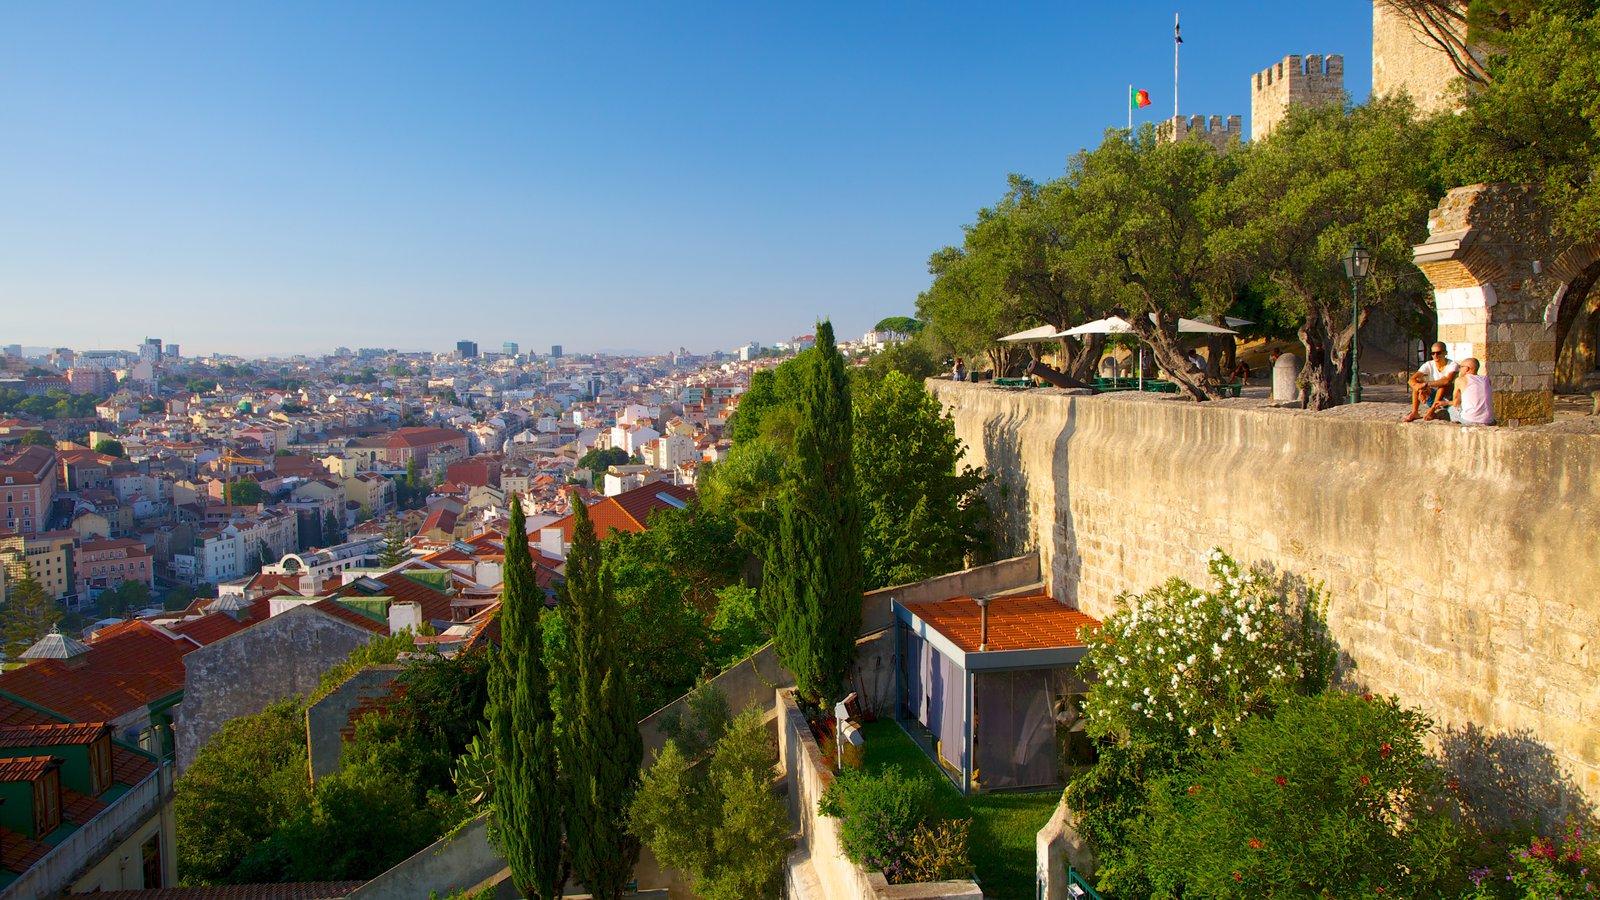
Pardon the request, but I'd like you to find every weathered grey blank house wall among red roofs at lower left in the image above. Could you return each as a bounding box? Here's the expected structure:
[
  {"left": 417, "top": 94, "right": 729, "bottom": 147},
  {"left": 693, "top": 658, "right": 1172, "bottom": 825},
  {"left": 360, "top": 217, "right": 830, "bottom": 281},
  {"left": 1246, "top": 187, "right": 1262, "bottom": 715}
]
[{"left": 173, "top": 607, "right": 373, "bottom": 773}]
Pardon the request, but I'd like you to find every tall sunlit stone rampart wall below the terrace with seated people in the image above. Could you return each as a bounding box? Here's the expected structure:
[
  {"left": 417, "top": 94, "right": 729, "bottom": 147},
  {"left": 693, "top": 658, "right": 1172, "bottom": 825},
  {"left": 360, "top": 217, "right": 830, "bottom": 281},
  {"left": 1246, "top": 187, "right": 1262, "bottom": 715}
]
[{"left": 930, "top": 381, "right": 1600, "bottom": 815}]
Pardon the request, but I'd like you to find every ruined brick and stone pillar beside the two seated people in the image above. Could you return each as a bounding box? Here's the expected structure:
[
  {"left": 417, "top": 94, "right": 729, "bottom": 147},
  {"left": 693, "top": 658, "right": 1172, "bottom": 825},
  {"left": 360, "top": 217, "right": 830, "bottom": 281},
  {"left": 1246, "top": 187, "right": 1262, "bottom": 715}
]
[{"left": 1414, "top": 184, "right": 1566, "bottom": 426}]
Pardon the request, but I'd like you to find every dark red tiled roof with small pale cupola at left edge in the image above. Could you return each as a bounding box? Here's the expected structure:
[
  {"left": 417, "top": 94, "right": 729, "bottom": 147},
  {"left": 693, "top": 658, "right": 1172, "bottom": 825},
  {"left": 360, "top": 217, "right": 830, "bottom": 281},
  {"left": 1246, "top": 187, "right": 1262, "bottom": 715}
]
[{"left": 0, "top": 618, "right": 195, "bottom": 722}]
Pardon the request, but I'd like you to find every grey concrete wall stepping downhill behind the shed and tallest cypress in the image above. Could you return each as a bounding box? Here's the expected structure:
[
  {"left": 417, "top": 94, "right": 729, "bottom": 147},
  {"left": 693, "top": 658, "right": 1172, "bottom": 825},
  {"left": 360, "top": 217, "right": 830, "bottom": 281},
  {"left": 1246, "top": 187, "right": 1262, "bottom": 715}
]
[{"left": 638, "top": 552, "right": 1038, "bottom": 761}]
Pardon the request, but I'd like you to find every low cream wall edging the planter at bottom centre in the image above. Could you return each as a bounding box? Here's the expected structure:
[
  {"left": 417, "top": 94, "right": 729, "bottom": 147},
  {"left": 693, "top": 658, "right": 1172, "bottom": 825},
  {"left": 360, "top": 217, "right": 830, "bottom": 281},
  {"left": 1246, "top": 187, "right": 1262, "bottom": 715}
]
[{"left": 774, "top": 692, "right": 982, "bottom": 900}]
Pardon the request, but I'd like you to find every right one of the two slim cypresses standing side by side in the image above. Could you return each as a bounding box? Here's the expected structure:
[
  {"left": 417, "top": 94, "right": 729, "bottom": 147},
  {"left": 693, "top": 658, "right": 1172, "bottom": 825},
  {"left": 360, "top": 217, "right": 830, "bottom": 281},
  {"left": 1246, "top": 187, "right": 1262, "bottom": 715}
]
[{"left": 560, "top": 496, "right": 645, "bottom": 900}]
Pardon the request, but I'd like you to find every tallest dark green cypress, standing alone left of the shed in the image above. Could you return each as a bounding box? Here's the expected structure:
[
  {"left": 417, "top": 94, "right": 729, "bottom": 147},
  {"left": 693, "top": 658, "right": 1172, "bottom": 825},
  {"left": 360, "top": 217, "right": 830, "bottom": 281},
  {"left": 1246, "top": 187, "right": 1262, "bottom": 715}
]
[{"left": 763, "top": 322, "right": 864, "bottom": 701}]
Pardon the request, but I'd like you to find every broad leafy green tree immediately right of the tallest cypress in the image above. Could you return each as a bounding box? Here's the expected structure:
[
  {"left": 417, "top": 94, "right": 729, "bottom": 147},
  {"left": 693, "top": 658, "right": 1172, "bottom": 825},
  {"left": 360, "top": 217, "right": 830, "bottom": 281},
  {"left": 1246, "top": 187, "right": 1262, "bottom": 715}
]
[{"left": 853, "top": 372, "right": 989, "bottom": 589}]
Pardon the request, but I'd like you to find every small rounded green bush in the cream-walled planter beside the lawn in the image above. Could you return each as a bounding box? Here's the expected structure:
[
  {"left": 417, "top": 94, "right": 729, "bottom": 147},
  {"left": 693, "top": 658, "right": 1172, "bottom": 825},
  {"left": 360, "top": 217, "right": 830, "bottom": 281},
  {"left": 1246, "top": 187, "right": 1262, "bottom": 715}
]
[{"left": 818, "top": 765, "right": 939, "bottom": 882}]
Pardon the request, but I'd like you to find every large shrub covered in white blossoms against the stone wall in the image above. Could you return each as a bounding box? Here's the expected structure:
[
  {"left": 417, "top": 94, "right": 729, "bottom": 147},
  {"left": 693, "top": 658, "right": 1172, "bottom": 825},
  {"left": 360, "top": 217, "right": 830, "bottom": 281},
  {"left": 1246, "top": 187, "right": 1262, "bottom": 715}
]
[{"left": 1067, "top": 551, "right": 1333, "bottom": 897}]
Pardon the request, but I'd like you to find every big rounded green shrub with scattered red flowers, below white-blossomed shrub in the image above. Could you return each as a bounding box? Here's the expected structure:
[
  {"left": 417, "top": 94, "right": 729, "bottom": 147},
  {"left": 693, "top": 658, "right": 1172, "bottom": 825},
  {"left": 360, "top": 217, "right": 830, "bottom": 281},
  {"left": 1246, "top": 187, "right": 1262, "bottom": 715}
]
[{"left": 1130, "top": 692, "right": 1472, "bottom": 897}]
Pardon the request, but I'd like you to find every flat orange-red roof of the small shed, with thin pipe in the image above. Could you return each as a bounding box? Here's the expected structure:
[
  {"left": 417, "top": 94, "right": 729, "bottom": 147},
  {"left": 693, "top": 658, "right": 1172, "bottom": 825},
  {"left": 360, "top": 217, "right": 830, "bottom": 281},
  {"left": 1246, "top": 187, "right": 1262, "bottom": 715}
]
[{"left": 904, "top": 594, "right": 1099, "bottom": 653}]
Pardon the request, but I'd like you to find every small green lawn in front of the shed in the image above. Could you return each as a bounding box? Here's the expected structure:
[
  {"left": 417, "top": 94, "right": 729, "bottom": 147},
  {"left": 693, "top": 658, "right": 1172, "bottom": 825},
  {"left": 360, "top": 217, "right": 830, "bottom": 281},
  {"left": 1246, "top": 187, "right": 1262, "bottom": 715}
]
[{"left": 862, "top": 721, "right": 1061, "bottom": 900}]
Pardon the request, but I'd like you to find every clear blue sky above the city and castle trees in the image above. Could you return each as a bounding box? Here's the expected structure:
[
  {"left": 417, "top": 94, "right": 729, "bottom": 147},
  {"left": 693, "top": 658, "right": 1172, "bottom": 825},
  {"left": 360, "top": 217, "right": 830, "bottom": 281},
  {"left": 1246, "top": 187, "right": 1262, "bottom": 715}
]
[{"left": 0, "top": 0, "right": 1371, "bottom": 354}]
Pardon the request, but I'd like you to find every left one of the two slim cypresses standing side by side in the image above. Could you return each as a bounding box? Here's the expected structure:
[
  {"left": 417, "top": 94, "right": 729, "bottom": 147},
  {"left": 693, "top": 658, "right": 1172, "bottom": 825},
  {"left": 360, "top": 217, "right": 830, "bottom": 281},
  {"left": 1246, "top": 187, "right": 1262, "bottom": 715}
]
[{"left": 488, "top": 504, "right": 566, "bottom": 900}]
